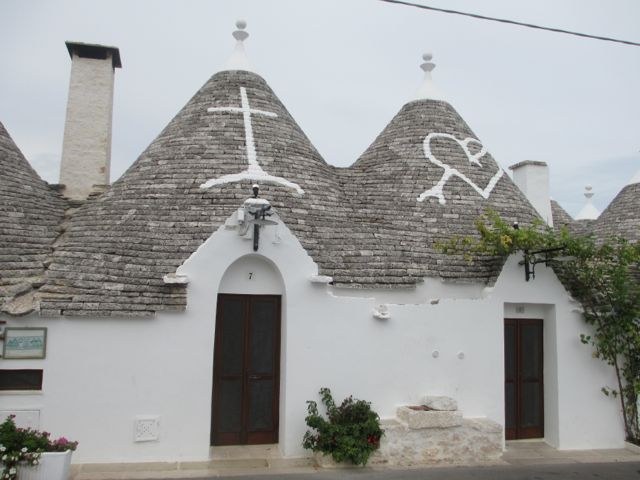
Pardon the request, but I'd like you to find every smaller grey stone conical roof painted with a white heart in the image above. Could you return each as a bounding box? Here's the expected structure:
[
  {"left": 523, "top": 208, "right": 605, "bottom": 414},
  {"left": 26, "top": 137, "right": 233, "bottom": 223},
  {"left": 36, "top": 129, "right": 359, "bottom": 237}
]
[{"left": 351, "top": 99, "right": 537, "bottom": 283}]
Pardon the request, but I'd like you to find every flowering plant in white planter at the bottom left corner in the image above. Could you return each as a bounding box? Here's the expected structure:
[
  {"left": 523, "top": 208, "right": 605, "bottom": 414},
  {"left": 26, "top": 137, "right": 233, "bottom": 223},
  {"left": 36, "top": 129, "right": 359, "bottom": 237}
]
[{"left": 0, "top": 415, "right": 78, "bottom": 480}]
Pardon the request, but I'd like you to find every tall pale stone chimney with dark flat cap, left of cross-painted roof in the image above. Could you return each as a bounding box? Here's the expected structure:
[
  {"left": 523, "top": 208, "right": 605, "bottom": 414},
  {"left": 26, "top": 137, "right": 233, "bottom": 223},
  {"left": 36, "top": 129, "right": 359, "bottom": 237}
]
[{"left": 60, "top": 42, "right": 122, "bottom": 200}]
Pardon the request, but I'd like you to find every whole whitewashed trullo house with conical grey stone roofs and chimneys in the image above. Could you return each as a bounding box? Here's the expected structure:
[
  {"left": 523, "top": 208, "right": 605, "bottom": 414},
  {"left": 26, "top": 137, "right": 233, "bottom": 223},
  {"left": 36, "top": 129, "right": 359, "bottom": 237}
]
[{"left": 0, "top": 23, "right": 640, "bottom": 463}]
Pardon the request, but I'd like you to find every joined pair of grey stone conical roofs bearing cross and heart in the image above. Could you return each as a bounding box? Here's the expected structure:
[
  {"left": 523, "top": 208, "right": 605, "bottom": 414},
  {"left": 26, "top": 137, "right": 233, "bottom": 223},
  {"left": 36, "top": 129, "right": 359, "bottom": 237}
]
[{"left": 41, "top": 57, "right": 536, "bottom": 315}]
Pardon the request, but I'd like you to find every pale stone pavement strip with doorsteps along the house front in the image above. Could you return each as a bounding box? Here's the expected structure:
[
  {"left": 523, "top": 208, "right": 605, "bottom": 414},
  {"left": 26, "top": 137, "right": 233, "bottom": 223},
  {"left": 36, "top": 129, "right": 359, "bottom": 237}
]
[{"left": 71, "top": 441, "right": 640, "bottom": 480}]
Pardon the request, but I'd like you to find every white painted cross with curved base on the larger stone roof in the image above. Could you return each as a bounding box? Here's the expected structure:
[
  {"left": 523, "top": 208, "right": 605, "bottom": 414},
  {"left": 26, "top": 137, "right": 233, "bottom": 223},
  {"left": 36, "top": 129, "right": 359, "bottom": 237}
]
[{"left": 200, "top": 87, "right": 304, "bottom": 194}]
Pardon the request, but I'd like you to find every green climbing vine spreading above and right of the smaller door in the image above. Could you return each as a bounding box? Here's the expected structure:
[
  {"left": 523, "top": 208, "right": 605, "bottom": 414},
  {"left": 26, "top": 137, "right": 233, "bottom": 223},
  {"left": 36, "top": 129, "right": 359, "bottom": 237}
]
[{"left": 440, "top": 212, "right": 640, "bottom": 444}]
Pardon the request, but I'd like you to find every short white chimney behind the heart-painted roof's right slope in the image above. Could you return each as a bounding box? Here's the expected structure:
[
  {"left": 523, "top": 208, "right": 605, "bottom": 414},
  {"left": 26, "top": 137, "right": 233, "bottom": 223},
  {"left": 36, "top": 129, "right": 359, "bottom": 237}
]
[{"left": 509, "top": 160, "right": 553, "bottom": 227}]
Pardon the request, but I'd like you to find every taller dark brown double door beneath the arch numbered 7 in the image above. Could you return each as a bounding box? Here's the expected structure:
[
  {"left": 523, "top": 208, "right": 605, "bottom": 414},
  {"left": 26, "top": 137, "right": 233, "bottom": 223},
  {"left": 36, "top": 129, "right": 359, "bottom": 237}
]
[{"left": 211, "top": 294, "right": 280, "bottom": 445}]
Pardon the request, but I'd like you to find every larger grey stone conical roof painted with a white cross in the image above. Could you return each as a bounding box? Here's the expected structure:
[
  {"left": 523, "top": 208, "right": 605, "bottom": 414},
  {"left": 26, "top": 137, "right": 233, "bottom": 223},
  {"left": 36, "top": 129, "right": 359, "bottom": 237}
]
[{"left": 42, "top": 70, "right": 347, "bottom": 315}]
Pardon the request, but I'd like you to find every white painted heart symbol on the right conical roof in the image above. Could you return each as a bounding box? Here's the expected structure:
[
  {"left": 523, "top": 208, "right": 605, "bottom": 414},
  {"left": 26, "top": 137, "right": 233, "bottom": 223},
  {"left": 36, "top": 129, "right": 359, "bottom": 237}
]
[{"left": 418, "top": 133, "right": 504, "bottom": 205}]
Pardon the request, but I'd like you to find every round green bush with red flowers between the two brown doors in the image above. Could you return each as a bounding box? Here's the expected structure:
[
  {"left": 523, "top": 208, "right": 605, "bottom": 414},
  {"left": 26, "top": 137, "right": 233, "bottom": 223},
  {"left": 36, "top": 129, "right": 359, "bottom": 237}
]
[{"left": 302, "top": 388, "right": 384, "bottom": 465}]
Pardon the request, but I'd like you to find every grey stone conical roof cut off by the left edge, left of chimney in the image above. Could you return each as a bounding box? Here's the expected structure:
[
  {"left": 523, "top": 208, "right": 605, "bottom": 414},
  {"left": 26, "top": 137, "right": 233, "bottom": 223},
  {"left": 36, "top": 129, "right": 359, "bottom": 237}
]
[{"left": 0, "top": 123, "right": 66, "bottom": 314}]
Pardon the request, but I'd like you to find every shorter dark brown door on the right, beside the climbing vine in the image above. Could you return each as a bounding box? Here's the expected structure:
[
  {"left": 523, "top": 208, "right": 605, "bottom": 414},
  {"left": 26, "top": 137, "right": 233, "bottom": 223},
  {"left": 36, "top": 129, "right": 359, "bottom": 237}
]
[{"left": 504, "top": 318, "right": 544, "bottom": 440}]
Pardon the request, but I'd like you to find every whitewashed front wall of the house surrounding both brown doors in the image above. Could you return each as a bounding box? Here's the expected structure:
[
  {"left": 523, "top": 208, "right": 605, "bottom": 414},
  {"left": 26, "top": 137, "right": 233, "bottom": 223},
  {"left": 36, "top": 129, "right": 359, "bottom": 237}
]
[{"left": 0, "top": 216, "right": 624, "bottom": 463}]
